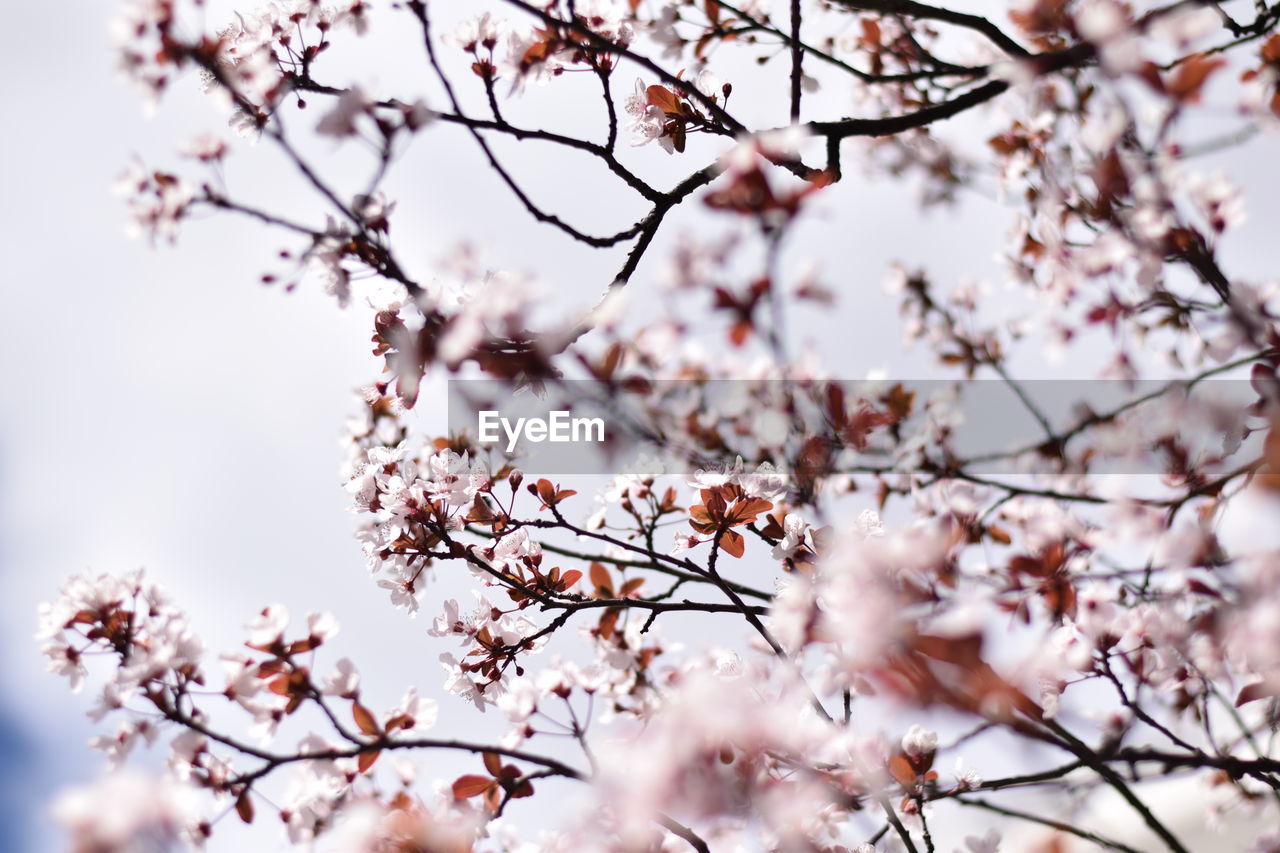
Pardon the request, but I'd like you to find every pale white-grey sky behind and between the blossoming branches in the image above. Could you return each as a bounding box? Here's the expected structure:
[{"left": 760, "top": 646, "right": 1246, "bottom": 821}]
[{"left": 0, "top": 1, "right": 1280, "bottom": 850}]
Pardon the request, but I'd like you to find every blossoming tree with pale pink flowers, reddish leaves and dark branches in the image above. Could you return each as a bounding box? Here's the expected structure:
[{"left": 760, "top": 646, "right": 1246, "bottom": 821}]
[{"left": 40, "top": 0, "right": 1280, "bottom": 853}]
